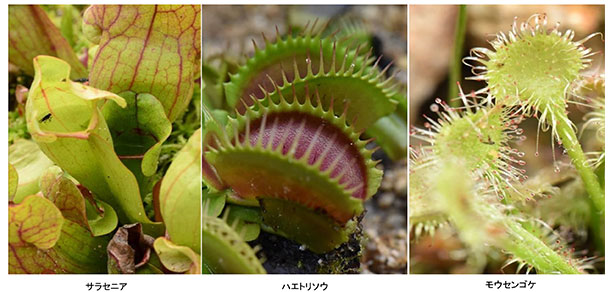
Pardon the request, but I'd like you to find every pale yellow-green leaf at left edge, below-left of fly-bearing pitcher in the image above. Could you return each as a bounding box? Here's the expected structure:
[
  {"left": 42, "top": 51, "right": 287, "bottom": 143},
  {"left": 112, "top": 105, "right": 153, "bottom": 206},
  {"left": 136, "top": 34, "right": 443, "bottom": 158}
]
[{"left": 9, "top": 139, "right": 53, "bottom": 203}]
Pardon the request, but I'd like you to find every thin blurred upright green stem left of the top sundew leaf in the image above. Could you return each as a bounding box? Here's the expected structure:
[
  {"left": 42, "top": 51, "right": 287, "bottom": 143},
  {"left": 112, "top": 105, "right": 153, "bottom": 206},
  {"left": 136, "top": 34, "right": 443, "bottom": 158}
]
[{"left": 448, "top": 5, "right": 467, "bottom": 107}]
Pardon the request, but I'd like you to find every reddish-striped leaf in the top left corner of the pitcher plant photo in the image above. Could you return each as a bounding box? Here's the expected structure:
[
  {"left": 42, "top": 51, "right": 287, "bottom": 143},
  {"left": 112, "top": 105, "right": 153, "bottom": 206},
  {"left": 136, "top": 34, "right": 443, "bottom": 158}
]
[{"left": 9, "top": 5, "right": 88, "bottom": 79}]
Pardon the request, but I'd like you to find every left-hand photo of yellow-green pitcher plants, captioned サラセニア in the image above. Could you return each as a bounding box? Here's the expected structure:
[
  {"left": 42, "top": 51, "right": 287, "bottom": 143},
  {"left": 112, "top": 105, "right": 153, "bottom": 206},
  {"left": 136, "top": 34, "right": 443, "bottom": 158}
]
[{"left": 8, "top": 5, "right": 202, "bottom": 274}]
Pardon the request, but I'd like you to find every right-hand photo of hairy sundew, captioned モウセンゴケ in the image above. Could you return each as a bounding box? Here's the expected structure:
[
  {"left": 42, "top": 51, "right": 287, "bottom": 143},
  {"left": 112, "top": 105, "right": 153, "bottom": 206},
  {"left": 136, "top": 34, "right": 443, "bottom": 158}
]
[{"left": 409, "top": 5, "right": 606, "bottom": 274}]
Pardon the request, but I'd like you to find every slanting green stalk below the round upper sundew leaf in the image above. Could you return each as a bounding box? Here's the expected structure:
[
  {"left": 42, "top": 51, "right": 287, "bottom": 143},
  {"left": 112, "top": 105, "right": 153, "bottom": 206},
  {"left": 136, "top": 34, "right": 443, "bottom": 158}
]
[{"left": 555, "top": 113, "right": 604, "bottom": 216}]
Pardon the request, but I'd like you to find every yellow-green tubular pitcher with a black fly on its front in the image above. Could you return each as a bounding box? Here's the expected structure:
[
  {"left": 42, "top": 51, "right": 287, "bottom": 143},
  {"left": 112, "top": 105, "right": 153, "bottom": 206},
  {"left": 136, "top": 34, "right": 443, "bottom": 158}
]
[{"left": 26, "top": 56, "right": 162, "bottom": 234}]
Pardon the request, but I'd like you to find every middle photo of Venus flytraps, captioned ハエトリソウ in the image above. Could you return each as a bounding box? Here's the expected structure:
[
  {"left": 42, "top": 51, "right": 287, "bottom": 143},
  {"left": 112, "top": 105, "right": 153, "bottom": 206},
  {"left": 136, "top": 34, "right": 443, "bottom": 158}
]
[{"left": 202, "top": 5, "right": 408, "bottom": 274}]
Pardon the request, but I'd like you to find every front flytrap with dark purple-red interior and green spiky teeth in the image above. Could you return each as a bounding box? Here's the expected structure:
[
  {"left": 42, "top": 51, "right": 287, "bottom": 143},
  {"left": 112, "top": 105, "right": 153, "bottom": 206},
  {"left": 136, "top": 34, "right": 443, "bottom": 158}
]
[{"left": 205, "top": 91, "right": 382, "bottom": 253}]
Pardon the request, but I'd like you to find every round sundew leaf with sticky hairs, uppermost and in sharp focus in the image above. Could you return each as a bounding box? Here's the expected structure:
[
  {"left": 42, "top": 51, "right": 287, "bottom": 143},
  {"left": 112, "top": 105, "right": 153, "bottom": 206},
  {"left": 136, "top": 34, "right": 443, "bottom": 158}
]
[{"left": 463, "top": 14, "right": 598, "bottom": 117}]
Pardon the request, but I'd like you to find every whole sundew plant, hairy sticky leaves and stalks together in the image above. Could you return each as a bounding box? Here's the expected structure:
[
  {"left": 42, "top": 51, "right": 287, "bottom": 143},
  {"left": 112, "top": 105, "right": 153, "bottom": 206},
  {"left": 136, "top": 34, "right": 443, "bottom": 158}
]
[{"left": 409, "top": 14, "right": 605, "bottom": 274}]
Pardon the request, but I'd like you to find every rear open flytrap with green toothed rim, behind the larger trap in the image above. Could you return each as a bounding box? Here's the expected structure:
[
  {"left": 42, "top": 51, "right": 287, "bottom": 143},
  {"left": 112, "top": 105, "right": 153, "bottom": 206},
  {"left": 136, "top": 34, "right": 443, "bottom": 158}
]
[{"left": 224, "top": 27, "right": 372, "bottom": 113}]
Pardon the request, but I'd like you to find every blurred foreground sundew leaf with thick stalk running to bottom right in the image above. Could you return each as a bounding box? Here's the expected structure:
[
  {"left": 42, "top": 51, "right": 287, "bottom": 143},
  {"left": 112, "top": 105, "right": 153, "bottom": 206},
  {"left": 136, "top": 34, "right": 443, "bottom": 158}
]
[{"left": 437, "top": 156, "right": 579, "bottom": 274}]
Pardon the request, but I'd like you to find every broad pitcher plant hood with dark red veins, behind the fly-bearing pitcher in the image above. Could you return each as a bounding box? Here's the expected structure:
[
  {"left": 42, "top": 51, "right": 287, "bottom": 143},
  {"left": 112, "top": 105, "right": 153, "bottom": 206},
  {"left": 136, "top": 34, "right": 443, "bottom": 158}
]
[{"left": 83, "top": 5, "right": 201, "bottom": 122}]
